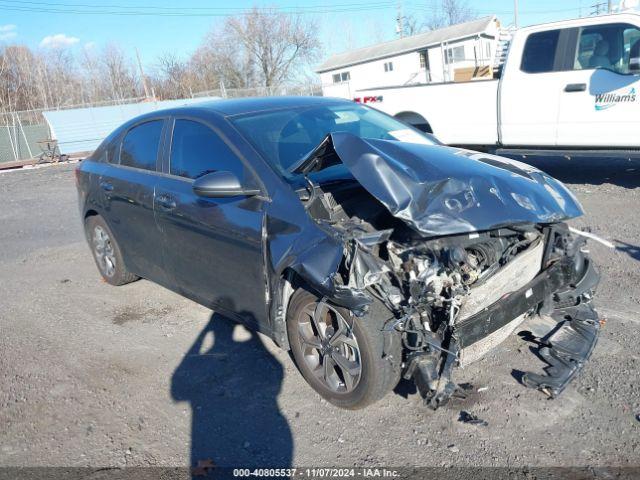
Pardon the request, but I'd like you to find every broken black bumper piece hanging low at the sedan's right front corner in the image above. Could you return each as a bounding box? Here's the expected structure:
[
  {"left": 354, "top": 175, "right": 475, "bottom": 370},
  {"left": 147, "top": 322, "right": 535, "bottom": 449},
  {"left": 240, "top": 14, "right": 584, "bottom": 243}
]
[{"left": 522, "top": 304, "right": 600, "bottom": 398}]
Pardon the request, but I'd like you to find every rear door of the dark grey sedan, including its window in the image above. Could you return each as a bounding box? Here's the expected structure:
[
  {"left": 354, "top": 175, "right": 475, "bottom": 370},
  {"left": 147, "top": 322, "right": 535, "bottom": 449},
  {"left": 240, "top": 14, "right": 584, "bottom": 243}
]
[{"left": 98, "top": 118, "right": 166, "bottom": 284}]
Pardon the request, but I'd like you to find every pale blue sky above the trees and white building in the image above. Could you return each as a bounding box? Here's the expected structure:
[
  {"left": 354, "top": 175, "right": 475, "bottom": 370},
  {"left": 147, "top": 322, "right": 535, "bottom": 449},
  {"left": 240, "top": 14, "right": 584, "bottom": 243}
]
[{"left": 0, "top": 0, "right": 596, "bottom": 67}]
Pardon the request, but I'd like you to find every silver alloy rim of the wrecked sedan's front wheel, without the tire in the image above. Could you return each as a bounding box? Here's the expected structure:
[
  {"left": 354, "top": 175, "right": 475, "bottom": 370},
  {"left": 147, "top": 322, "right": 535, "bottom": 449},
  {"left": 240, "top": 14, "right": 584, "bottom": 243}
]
[{"left": 298, "top": 301, "right": 362, "bottom": 393}]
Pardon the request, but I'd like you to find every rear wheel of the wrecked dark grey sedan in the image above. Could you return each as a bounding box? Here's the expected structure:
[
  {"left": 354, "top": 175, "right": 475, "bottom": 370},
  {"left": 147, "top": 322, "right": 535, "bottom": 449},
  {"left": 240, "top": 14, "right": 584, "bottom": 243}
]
[{"left": 84, "top": 215, "right": 139, "bottom": 286}]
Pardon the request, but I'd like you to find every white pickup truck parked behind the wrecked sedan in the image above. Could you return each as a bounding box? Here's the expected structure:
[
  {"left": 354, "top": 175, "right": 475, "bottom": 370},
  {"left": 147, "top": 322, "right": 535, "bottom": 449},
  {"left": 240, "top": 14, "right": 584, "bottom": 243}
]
[{"left": 355, "top": 13, "right": 640, "bottom": 151}]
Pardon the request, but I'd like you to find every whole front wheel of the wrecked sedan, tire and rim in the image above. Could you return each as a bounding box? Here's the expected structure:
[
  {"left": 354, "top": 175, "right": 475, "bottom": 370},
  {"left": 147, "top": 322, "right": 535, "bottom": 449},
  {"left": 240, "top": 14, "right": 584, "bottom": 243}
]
[{"left": 287, "top": 288, "right": 402, "bottom": 410}]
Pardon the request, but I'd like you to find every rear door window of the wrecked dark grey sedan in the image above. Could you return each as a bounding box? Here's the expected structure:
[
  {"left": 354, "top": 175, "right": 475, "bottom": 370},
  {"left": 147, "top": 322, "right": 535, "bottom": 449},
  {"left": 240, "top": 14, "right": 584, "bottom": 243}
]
[{"left": 120, "top": 120, "right": 164, "bottom": 171}]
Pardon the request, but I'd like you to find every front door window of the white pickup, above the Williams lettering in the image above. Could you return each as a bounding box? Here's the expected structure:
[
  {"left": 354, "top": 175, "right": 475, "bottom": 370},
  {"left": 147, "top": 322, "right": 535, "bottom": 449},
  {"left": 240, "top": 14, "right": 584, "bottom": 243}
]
[{"left": 574, "top": 23, "right": 640, "bottom": 74}]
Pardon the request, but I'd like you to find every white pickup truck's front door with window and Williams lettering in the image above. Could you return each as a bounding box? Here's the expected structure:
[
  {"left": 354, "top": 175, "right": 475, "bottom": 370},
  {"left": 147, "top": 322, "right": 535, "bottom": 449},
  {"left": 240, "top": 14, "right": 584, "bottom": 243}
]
[{"left": 557, "top": 23, "right": 640, "bottom": 147}]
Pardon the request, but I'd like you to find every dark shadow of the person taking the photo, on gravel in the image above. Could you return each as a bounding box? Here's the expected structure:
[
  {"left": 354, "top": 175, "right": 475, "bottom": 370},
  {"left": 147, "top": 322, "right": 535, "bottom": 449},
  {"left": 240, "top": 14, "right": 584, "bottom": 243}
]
[{"left": 171, "top": 314, "right": 293, "bottom": 468}]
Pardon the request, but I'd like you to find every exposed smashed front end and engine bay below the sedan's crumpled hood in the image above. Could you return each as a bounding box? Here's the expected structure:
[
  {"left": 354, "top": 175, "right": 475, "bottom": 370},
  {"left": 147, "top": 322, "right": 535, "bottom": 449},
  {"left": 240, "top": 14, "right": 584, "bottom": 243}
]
[{"left": 299, "top": 176, "right": 599, "bottom": 408}]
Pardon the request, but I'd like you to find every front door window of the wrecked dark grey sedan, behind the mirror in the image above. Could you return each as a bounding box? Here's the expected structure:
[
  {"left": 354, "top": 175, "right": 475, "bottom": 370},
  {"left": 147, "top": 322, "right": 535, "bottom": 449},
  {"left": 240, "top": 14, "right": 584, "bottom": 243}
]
[{"left": 170, "top": 119, "right": 244, "bottom": 181}]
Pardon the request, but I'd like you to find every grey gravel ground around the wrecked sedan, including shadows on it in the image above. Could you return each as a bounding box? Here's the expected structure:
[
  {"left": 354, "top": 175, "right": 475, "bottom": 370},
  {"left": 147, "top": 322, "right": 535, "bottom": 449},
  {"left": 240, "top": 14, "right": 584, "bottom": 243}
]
[{"left": 0, "top": 159, "right": 640, "bottom": 467}]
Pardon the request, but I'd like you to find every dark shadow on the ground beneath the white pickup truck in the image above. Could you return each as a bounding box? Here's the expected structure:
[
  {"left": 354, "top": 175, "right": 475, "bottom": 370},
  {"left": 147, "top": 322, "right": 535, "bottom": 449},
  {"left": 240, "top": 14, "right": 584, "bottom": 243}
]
[{"left": 500, "top": 155, "right": 640, "bottom": 188}]
